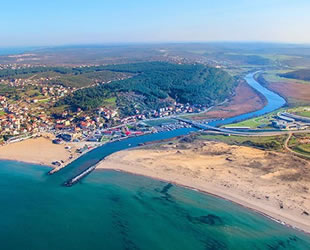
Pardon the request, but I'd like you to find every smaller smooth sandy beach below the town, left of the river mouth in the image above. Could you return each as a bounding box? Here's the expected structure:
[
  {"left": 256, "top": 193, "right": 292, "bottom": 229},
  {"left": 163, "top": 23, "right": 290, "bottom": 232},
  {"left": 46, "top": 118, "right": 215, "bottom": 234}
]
[{"left": 0, "top": 137, "right": 77, "bottom": 166}]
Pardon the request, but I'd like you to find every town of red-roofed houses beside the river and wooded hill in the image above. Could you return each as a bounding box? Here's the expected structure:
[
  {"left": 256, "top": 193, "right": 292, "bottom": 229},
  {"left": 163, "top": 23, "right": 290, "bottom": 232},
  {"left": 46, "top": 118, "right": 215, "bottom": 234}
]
[{"left": 0, "top": 65, "right": 207, "bottom": 147}]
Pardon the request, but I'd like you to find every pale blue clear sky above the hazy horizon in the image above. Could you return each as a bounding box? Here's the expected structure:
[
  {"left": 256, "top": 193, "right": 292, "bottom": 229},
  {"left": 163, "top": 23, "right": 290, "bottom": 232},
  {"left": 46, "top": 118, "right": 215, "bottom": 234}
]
[{"left": 0, "top": 0, "right": 310, "bottom": 47}]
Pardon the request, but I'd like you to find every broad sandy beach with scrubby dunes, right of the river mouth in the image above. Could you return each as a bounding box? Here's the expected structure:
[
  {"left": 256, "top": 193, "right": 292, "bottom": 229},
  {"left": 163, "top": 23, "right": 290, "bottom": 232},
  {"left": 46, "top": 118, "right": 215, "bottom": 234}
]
[{"left": 97, "top": 141, "right": 310, "bottom": 233}]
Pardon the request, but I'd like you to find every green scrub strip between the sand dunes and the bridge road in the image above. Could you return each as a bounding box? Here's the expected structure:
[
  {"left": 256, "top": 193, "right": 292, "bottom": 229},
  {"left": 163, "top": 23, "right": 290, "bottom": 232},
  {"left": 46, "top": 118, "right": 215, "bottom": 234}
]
[{"left": 197, "top": 133, "right": 287, "bottom": 151}]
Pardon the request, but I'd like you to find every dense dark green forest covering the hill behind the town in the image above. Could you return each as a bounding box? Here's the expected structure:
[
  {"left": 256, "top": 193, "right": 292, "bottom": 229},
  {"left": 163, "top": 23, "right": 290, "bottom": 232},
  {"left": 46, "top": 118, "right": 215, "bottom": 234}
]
[{"left": 57, "top": 62, "right": 235, "bottom": 115}]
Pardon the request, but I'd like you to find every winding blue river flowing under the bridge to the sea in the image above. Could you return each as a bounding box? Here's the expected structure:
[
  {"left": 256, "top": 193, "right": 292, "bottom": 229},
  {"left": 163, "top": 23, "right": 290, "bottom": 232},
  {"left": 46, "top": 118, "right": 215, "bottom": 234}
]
[{"left": 52, "top": 72, "right": 286, "bottom": 187}]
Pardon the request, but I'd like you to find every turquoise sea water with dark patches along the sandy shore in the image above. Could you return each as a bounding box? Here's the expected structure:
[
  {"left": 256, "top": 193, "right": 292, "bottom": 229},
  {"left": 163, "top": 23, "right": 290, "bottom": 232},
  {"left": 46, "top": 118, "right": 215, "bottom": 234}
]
[{"left": 0, "top": 161, "right": 310, "bottom": 250}]
